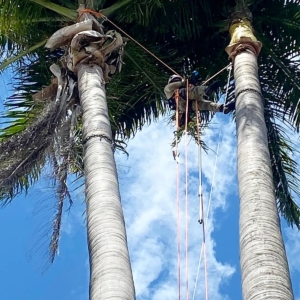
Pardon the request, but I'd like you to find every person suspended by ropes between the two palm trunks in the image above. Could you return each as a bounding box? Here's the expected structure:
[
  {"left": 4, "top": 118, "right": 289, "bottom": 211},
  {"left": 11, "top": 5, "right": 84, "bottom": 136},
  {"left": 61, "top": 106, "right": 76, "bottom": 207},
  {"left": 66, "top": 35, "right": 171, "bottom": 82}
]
[{"left": 164, "top": 71, "right": 235, "bottom": 126}]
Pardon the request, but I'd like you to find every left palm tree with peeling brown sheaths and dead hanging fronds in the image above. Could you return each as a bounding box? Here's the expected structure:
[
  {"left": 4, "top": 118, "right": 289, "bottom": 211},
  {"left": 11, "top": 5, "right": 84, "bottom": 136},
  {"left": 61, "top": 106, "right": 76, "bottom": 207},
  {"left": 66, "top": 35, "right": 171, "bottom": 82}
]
[{"left": 1, "top": 1, "right": 168, "bottom": 299}]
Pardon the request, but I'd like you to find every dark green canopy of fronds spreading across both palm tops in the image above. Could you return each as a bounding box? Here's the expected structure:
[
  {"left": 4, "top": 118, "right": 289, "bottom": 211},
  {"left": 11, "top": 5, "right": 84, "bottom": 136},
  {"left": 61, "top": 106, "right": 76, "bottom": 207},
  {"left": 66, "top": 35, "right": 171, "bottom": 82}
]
[{"left": 0, "top": 0, "right": 300, "bottom": 264}]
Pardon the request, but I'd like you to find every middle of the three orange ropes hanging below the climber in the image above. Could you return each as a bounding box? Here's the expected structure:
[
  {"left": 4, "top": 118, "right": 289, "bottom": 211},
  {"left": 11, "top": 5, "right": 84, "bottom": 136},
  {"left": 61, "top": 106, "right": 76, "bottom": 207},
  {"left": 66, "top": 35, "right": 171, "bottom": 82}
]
[{"left": 185, "top": 79, "right": 189, "bottom": 300}]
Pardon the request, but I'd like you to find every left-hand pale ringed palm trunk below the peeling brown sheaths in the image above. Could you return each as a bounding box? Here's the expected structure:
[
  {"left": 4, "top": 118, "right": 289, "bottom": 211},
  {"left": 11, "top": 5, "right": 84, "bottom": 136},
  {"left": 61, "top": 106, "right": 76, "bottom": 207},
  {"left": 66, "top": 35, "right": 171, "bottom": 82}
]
[{"left": 77, "top": 64, "right": 135, "bottom": 300}]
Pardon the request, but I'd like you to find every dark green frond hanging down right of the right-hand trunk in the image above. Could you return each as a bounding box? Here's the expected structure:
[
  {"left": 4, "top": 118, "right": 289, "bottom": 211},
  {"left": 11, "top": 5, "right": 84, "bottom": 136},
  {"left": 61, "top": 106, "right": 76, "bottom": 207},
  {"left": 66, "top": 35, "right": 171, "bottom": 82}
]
[{"left": 225, "top": 74, "right": 300, "bottom": 229}]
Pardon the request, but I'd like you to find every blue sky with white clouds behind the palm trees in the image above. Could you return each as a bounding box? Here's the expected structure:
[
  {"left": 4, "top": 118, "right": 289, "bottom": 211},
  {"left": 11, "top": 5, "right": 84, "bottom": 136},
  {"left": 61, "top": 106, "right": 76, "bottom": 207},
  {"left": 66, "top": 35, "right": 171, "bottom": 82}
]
[{"left": 0, "top": 71, "right": 300, "bottom": 300}]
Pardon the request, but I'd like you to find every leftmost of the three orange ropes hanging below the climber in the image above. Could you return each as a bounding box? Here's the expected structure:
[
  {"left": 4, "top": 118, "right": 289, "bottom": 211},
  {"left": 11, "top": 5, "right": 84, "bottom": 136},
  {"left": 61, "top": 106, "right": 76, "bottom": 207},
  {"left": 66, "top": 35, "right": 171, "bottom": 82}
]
[{"left": 175, "top": 90, "right": 181, "bottom": 300}]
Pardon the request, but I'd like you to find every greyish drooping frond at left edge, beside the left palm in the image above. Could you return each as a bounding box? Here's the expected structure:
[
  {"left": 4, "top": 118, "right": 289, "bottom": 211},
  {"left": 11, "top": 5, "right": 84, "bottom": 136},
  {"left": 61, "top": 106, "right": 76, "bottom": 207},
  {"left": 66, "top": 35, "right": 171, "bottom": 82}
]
[{"left": 0, "top": 102, "right": 59, "bottom": 205}]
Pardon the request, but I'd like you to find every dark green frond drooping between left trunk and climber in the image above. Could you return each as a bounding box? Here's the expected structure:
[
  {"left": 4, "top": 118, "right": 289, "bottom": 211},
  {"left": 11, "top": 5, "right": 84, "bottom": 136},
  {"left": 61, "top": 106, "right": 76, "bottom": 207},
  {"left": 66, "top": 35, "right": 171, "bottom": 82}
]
[{"left": 107, "top": 42, "right": 172, "bottom": 139}]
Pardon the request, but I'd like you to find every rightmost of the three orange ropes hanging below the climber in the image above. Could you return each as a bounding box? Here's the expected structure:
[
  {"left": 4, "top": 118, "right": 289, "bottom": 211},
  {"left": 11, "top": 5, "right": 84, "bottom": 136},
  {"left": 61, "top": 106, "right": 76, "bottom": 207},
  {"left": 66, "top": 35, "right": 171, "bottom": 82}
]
[{"left": 195, "top": 99, "right": 208, "bottom": 300}]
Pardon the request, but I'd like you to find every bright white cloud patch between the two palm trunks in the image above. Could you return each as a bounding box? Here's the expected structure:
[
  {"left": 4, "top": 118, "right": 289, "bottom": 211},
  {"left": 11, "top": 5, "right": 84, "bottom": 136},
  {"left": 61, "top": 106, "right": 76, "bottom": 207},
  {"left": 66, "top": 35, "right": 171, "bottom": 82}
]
[{"left": 117, "top": 113, "right": 236, "bottom": 300}]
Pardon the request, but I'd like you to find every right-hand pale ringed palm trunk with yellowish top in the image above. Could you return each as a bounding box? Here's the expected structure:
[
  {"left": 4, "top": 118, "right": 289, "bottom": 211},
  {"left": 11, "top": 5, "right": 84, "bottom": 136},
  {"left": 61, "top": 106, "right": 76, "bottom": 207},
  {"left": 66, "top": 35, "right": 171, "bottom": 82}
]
[{"left": 226, "top": 13, "right": 294, "bottom": 300}]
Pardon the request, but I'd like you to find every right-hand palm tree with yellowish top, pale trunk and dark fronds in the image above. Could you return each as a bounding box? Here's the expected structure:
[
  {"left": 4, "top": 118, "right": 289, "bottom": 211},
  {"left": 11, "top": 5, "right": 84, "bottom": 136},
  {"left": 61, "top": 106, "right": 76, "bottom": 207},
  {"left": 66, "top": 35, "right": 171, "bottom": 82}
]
[{"left": 126, "top": 1, "right": 300, "bottom": 299}]
